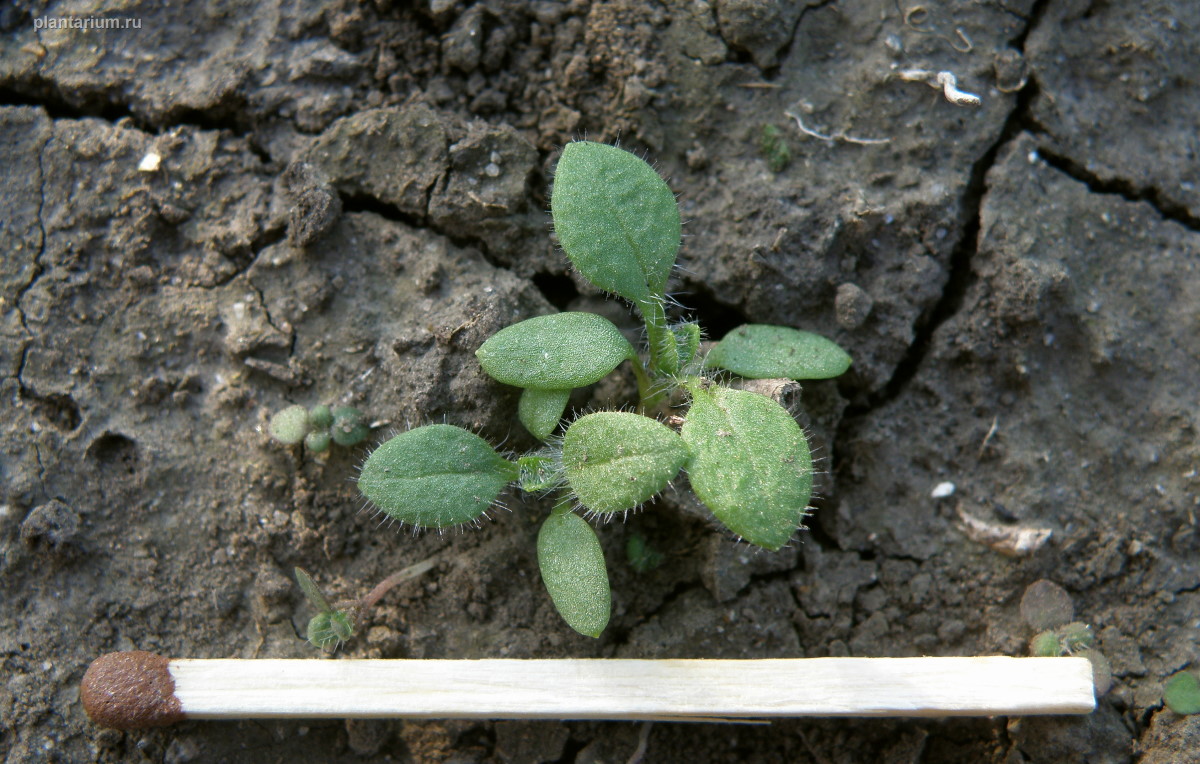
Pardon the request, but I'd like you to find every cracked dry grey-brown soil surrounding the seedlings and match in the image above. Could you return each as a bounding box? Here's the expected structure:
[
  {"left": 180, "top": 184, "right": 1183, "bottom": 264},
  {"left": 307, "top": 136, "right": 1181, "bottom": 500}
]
[{"left": 0, "top": 0, "right": 1200, "bottom": 764}]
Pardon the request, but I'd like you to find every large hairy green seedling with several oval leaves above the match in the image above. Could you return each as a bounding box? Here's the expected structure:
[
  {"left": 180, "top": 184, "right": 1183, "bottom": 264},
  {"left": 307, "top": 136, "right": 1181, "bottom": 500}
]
[{"left": 358, "top": 142, "right": 850, "bottom": 637}]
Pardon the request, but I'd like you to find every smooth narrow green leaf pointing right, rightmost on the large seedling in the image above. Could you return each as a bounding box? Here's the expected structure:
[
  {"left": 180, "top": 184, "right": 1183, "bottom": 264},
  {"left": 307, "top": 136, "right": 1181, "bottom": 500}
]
[{"left": 704, "top": 324, "right": 851, "bottom": 379}]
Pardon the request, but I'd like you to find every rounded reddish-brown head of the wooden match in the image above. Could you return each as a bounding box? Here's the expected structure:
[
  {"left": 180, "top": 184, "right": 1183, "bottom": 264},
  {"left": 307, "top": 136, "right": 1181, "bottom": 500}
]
[{"left": 79, "top": 650, "right": 184, "bottom": 729}]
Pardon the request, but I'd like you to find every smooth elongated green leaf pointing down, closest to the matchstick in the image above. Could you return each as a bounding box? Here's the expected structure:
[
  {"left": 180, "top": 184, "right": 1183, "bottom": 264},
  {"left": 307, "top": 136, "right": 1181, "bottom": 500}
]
[{"left": 538, "top": 510, "right": 612, "bottom": 637}]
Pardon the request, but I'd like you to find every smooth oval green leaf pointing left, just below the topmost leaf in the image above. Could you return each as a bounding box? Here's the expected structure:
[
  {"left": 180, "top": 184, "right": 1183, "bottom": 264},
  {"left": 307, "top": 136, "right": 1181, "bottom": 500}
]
[{"left": 475, "top": 313, "right": 635, "bottom": 390}]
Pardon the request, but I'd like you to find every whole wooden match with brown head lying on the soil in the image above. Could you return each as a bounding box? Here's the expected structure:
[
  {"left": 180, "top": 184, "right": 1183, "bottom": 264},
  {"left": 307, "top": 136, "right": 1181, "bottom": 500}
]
[{"left": 80, "top": 651, "right": 1096, "bottom": 729}]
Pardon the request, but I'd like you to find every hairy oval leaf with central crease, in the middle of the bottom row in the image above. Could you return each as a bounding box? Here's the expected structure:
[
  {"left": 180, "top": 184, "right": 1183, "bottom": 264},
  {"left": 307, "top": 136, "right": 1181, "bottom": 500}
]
[{"left": 563, "top": 411, "right": 688, "bottom": 512}]
